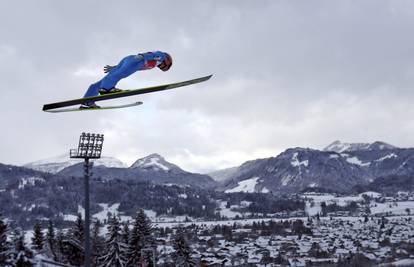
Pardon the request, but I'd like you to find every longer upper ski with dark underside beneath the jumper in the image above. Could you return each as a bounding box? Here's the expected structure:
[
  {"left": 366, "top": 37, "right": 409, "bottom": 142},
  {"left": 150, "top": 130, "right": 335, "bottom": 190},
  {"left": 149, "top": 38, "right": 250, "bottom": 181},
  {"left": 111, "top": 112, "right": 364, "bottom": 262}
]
[{"left": 43, "top": 75, "right": 213, "bottom": 111}]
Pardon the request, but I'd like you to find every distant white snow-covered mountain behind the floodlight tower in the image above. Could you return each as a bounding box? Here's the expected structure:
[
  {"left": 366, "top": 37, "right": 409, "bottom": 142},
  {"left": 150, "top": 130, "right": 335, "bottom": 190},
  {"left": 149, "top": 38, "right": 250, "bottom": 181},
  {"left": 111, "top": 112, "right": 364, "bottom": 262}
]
[{"left": 24, "top": 153, "right": 127, "bottom": 173}]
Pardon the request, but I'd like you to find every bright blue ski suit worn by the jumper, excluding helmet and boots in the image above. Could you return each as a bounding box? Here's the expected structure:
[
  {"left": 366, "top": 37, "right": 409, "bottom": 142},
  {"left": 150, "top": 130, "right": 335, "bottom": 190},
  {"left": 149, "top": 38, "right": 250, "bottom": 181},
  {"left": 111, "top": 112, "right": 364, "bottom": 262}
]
[{"left": 84, "top": 51, "right": 166, "bottom": 97}]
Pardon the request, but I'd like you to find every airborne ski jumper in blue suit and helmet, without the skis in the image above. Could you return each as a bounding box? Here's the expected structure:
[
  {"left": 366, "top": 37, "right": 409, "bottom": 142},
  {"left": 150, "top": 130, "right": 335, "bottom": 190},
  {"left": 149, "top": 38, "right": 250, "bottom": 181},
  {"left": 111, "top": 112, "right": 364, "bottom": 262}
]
[{"left": 80, "top": 51, "right": 172, "bottom": 109}]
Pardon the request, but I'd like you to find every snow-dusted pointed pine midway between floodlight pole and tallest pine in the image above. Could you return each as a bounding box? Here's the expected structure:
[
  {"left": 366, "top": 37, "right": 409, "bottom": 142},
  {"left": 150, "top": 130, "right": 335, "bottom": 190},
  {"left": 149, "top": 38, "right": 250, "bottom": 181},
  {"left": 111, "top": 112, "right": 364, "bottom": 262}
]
[{"left": 100, "top": 216, "right": 126, "bottom": 267}]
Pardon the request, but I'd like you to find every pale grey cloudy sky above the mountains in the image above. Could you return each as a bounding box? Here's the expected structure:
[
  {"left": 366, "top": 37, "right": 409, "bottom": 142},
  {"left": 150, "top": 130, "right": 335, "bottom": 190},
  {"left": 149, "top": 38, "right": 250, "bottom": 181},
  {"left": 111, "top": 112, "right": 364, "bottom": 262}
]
[{"left": 0, "top": 0, "right": 414, "bottom": 172}]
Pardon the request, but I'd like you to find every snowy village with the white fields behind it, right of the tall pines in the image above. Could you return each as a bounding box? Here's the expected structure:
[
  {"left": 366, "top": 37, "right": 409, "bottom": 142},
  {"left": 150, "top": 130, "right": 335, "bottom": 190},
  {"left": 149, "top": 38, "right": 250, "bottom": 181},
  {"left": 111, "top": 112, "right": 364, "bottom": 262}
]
[{"left": 154, "top": 192, "right": 414, "bottom": 266}]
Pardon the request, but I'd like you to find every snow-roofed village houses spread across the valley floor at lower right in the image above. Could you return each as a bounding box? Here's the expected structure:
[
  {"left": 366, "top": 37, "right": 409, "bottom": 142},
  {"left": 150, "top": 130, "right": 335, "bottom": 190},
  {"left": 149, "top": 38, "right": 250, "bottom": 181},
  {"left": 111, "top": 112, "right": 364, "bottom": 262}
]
[{"left": 158, "top": 216, "right": 414, "bottom": 266}]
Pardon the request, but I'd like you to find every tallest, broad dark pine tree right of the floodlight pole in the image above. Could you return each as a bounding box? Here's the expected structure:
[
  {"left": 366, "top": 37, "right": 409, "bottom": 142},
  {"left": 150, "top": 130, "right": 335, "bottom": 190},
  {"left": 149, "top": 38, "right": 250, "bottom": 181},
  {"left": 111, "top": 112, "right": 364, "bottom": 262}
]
[{"left": 127, "top": 209, "right": 155, "bottom": 266}]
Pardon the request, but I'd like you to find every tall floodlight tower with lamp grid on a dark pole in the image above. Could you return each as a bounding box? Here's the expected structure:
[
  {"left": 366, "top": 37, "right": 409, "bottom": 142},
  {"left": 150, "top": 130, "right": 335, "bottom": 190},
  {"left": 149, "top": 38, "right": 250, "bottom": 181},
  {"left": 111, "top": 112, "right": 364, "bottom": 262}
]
[{"left": 70, "top": 133, "right": 104, "bottom": 267}]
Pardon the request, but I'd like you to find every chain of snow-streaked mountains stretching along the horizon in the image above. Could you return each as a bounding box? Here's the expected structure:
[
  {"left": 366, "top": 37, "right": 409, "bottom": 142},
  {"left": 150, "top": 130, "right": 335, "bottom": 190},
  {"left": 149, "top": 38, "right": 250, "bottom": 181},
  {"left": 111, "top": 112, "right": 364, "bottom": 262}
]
[{"left": 15, "top": 141, "right": 414, "bottom": 193}]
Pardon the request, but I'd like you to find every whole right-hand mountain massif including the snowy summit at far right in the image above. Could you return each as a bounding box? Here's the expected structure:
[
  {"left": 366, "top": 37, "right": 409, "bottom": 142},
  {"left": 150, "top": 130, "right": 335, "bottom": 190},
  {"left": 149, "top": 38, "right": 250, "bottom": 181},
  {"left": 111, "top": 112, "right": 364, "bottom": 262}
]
[{"left": 221, "top": 142, "right": 414, "bottom": 193}]
